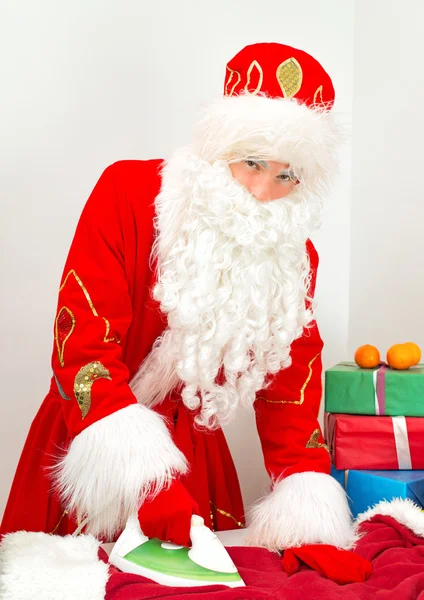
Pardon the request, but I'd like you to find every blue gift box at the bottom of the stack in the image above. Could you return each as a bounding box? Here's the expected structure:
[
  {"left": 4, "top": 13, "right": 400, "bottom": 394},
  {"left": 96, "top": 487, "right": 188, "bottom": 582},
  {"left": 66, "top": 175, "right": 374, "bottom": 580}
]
[{"left": 331, "top": 467, "right": 424, "bottom": 517}]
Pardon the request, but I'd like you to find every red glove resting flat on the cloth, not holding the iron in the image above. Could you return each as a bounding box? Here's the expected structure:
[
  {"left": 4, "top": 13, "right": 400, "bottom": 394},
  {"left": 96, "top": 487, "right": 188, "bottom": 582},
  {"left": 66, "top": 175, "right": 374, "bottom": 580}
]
[{"left": 282, "top": 544, "right": 372, "bottom": 585}]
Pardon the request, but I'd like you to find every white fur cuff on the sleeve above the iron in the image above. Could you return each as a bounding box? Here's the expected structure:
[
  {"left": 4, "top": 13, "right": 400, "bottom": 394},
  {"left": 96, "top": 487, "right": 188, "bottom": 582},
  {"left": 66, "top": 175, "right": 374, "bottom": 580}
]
[{"left": 54, "top": 404, "right": 187, "bottom": 541}]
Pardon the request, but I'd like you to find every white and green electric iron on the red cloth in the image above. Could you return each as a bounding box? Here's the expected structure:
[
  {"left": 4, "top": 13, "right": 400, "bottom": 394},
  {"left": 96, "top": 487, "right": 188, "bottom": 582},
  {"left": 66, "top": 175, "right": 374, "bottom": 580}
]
[{"left": 109, "top": 515, "right": 245, "bottom": 587}]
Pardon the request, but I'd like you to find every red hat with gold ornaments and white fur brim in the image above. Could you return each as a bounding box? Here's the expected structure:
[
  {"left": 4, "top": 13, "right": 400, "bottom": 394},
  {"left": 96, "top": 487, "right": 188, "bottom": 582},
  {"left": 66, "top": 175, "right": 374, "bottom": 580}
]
[{"left": 194, "top": 43, "right": 341, "bottom": 192}]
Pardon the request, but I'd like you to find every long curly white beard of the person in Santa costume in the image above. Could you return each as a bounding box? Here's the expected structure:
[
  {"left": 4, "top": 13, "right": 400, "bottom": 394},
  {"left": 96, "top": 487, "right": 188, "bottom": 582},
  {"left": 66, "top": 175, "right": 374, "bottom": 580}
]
[{"left": 131, "top": 150, "right": 321, "bottom": 428}]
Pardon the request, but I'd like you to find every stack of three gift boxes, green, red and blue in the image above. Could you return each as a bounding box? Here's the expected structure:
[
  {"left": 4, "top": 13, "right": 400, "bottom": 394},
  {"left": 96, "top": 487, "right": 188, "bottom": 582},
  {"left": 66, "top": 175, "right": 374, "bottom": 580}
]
[{"left": 325, "top": 362, "right": 424, "bottom": 516}]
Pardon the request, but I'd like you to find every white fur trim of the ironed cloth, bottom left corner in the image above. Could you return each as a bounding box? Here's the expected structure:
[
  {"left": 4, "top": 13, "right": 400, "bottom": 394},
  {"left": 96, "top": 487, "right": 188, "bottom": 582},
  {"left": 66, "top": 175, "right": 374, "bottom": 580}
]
[{"left": 0, "top": 531, "right": 109, "bottom": 600}]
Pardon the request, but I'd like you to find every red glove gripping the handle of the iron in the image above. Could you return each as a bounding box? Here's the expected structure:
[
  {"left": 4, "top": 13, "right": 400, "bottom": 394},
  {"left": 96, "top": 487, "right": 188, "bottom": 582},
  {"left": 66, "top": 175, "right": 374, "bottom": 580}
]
[{"left": 138, "top": 479, "right": 199, "bottom": 546}]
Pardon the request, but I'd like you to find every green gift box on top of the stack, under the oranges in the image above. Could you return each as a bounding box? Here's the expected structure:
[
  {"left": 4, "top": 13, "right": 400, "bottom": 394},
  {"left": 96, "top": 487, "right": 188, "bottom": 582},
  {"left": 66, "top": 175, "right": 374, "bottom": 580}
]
[{"left": 325, "top": 362, "right": 424, "bottom": 417}]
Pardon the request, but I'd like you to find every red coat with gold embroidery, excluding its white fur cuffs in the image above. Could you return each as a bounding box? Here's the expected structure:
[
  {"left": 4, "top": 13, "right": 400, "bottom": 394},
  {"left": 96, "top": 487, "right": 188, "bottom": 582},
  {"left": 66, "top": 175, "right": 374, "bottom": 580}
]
[{"left": 1, "top": 160, "right": 330, "bottom": 534}]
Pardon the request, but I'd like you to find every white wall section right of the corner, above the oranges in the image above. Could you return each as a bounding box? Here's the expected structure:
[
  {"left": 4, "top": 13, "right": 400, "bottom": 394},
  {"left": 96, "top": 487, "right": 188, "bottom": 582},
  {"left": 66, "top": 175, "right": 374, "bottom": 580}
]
[{"left": 348, "top": 0, "right": 424, "bottom": 356}]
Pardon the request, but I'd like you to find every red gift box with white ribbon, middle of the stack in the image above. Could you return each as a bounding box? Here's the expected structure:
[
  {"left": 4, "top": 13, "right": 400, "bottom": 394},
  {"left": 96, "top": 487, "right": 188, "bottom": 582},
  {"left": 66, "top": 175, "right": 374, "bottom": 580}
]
[{"left": 325, "top": 414, "right": 424, "bottom": 470}]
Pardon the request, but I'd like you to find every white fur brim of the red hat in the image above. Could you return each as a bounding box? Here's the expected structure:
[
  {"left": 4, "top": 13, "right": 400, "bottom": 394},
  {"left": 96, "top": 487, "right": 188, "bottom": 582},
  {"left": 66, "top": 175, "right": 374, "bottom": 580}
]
[{"left": 194, "top": 94, "right": 342, "bottom": 193}]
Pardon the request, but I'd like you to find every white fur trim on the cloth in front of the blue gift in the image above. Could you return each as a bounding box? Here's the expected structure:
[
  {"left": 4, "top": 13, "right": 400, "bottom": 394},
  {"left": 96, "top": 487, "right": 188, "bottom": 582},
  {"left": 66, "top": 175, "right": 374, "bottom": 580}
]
[{"left": 354, "top": 498, "right": 424, "bottom": 537}]
